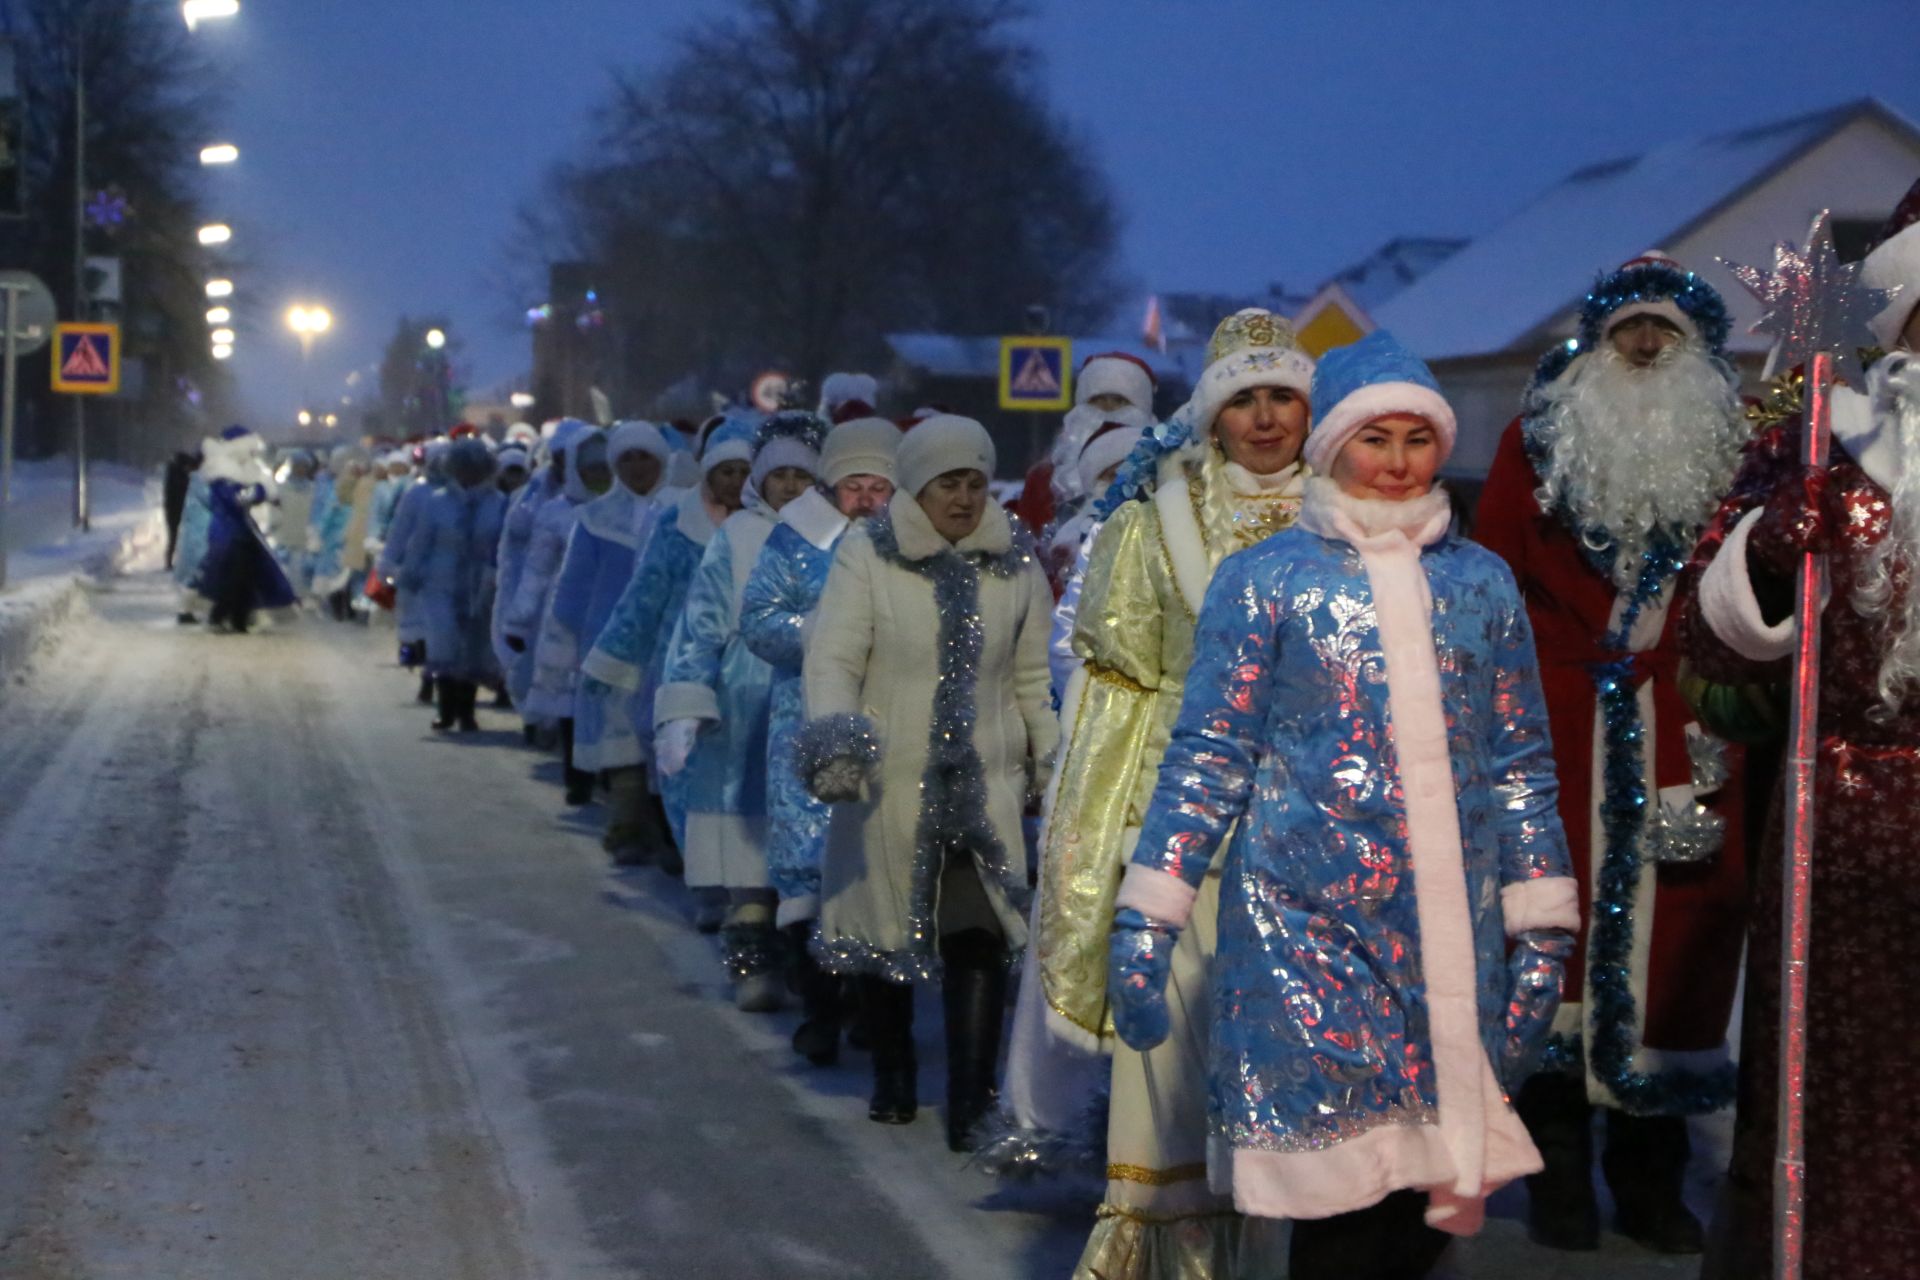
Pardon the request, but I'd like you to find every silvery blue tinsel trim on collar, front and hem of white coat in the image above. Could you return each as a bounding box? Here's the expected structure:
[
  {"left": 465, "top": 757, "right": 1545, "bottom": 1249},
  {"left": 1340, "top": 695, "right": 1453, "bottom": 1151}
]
[{"left": 803, "top": 514, "right": 1039, "bottom": 983}]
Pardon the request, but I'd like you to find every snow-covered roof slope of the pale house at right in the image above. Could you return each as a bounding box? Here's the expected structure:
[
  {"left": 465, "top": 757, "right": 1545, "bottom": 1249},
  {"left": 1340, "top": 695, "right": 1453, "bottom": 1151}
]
[{"left": 1373, "top": 98, "right": 1912, "bottom": 359}]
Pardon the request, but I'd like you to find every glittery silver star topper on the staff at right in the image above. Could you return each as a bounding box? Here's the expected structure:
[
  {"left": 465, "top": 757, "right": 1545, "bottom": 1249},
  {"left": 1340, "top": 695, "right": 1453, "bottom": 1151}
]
[{"left": 1716, "top": 209, "right": 1901, "bottom": 388}]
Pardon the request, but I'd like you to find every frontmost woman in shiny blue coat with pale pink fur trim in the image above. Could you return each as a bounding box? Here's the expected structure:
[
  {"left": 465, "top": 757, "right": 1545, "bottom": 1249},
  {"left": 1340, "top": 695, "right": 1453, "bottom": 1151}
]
[{"left": 1110, "top": 332, "right": 1578, "bottom": 1280}]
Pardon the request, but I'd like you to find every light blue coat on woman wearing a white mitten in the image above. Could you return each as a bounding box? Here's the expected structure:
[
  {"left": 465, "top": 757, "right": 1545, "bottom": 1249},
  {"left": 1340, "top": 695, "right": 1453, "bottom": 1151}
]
[{"left": 653, "top": 505, "right": 774, "bottom": 818}]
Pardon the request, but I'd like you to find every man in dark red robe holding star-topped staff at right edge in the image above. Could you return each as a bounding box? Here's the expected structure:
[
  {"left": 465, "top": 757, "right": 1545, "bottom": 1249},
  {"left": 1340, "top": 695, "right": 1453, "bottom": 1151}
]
[{"left": 1682, "top": 182, "right": 1920, "bottom": 1280}]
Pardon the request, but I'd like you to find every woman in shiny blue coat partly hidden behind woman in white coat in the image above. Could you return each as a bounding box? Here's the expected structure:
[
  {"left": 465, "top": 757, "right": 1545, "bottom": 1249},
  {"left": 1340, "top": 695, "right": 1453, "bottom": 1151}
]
[{"left": 739, "top": 418, "right": 900, "bottom": 1067}]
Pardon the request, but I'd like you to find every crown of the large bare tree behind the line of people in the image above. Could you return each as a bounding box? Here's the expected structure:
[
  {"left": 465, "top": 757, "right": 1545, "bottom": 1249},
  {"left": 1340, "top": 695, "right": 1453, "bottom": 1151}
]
[{"left": 516, "top": 0, "right": 1116, "bottom": 410}]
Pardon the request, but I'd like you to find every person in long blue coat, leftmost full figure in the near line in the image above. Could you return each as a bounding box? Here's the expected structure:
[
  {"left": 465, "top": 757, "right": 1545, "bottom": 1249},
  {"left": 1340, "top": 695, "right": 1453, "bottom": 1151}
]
[{"left": 396, "top": 438, "right": 507, "bottom": 733}]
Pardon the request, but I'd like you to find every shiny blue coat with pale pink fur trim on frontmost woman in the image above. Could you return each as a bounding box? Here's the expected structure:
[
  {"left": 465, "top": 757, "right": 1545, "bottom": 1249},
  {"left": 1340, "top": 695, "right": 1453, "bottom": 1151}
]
[{"left": 1121, "top": 482, "right": 1576, "bottom": 1230}]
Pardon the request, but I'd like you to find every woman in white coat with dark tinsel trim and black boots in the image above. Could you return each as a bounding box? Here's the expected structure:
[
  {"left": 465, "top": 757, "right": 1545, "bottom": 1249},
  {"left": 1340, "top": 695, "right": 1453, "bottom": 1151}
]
[{"left": 795, "top": 415, "right": 1058, "bottom": 1150}]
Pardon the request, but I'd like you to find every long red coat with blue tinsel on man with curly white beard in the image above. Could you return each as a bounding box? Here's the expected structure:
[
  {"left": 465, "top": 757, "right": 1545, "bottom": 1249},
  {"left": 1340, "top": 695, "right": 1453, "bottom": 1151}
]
[{"left": 1475, "top": 418, "right": 1747, "bottom": 1115}]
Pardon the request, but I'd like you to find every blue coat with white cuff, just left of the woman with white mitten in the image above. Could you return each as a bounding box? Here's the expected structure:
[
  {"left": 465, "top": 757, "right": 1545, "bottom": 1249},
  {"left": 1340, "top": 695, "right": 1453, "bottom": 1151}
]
[{"left": 580, "top": 489, "right": 718, "bottom": 842}]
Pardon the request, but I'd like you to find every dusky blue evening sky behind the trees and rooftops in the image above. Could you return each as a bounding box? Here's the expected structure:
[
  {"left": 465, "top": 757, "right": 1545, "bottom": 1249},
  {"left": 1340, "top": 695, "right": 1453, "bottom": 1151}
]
[{"left": 198, "top": 0, "right": 1920, "bottom": 428}]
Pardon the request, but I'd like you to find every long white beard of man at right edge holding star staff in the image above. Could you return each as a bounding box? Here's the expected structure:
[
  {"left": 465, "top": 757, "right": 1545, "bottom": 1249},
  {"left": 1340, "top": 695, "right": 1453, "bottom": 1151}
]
[{"left": 1853, "top": 351, "right": 1920, "bottom": 716}]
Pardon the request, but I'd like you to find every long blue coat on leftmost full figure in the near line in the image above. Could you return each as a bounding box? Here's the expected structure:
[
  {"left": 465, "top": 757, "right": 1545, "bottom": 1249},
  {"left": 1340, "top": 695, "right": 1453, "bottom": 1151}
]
[{"left": 394, "top": 480, "right": 507, "bottom": 683}]
